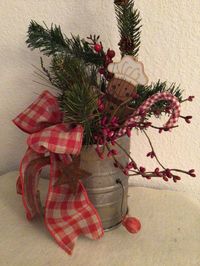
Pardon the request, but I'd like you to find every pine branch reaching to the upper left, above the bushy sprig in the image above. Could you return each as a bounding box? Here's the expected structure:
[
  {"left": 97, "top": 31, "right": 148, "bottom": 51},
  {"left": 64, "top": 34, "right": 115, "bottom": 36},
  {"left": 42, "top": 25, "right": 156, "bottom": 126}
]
[{"left": 26, "top": 21, "right": 105, "bottom": 67}]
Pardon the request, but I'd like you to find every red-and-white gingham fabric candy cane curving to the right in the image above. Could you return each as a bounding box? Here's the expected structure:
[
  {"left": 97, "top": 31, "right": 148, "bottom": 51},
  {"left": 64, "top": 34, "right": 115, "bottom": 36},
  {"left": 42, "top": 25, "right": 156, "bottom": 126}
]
[{"left": 118, "top": 92, "right": 180, "bottom": 136}]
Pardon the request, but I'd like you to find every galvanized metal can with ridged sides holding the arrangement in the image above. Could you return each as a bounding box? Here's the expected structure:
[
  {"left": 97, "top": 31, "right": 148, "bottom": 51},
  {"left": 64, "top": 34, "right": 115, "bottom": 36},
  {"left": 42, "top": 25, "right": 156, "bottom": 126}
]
[{"left": 81, "top": 137, "right": 130, "bottom": 230}]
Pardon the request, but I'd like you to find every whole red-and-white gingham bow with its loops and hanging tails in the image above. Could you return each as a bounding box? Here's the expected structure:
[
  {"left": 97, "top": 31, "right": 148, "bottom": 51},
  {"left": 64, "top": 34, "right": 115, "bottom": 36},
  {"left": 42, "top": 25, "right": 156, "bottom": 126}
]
[{"left": 13, "top": 91, "right": 104, "bottom": 254}]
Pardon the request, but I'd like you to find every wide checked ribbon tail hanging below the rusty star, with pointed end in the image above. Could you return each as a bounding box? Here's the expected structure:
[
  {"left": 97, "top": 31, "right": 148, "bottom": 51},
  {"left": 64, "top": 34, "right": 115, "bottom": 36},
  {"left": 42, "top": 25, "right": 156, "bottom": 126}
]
[{"left": 45, "top": 153, "right": 104, "bottom": 255}]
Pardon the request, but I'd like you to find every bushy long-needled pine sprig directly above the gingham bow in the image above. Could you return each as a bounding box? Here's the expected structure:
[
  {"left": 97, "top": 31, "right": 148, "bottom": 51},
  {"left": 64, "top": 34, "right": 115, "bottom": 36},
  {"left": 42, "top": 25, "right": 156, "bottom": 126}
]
[{"left": 41, "top": 55, "right": 103, "bottom": 145}]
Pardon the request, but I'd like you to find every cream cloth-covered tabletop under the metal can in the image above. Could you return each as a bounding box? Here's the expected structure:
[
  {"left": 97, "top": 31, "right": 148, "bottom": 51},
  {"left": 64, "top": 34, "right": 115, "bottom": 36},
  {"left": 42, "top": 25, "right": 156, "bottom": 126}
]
[{"left": 0, "top": 171, "right": 200, "bottom": 266}]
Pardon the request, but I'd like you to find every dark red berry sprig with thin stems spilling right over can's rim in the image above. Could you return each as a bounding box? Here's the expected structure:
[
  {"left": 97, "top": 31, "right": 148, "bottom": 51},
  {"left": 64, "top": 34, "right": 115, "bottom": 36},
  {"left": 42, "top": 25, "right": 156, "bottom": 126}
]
[{"left": 95, "top": 88, "right": 196, "bottom": 182}]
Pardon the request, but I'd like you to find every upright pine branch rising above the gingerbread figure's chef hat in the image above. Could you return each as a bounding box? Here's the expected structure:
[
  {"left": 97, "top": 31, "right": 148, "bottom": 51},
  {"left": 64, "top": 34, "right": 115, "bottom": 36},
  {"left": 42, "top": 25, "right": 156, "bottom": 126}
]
[{"left": 115, "top": 0, "right": 142, "bottom": 56}]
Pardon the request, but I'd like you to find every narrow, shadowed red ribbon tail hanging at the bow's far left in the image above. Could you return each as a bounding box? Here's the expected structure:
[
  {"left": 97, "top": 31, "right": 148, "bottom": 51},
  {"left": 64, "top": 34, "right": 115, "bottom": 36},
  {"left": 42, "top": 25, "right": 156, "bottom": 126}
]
[{"left": 17, "top": 148, "right": 50, "bottom": 220}]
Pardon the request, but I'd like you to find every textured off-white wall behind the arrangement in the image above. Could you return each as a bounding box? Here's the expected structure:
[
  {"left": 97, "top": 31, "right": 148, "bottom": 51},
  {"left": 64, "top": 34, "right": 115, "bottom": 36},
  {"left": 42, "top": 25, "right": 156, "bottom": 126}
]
[{"left": 0, "top": 0, "right": 200, "bottom": 198}]
